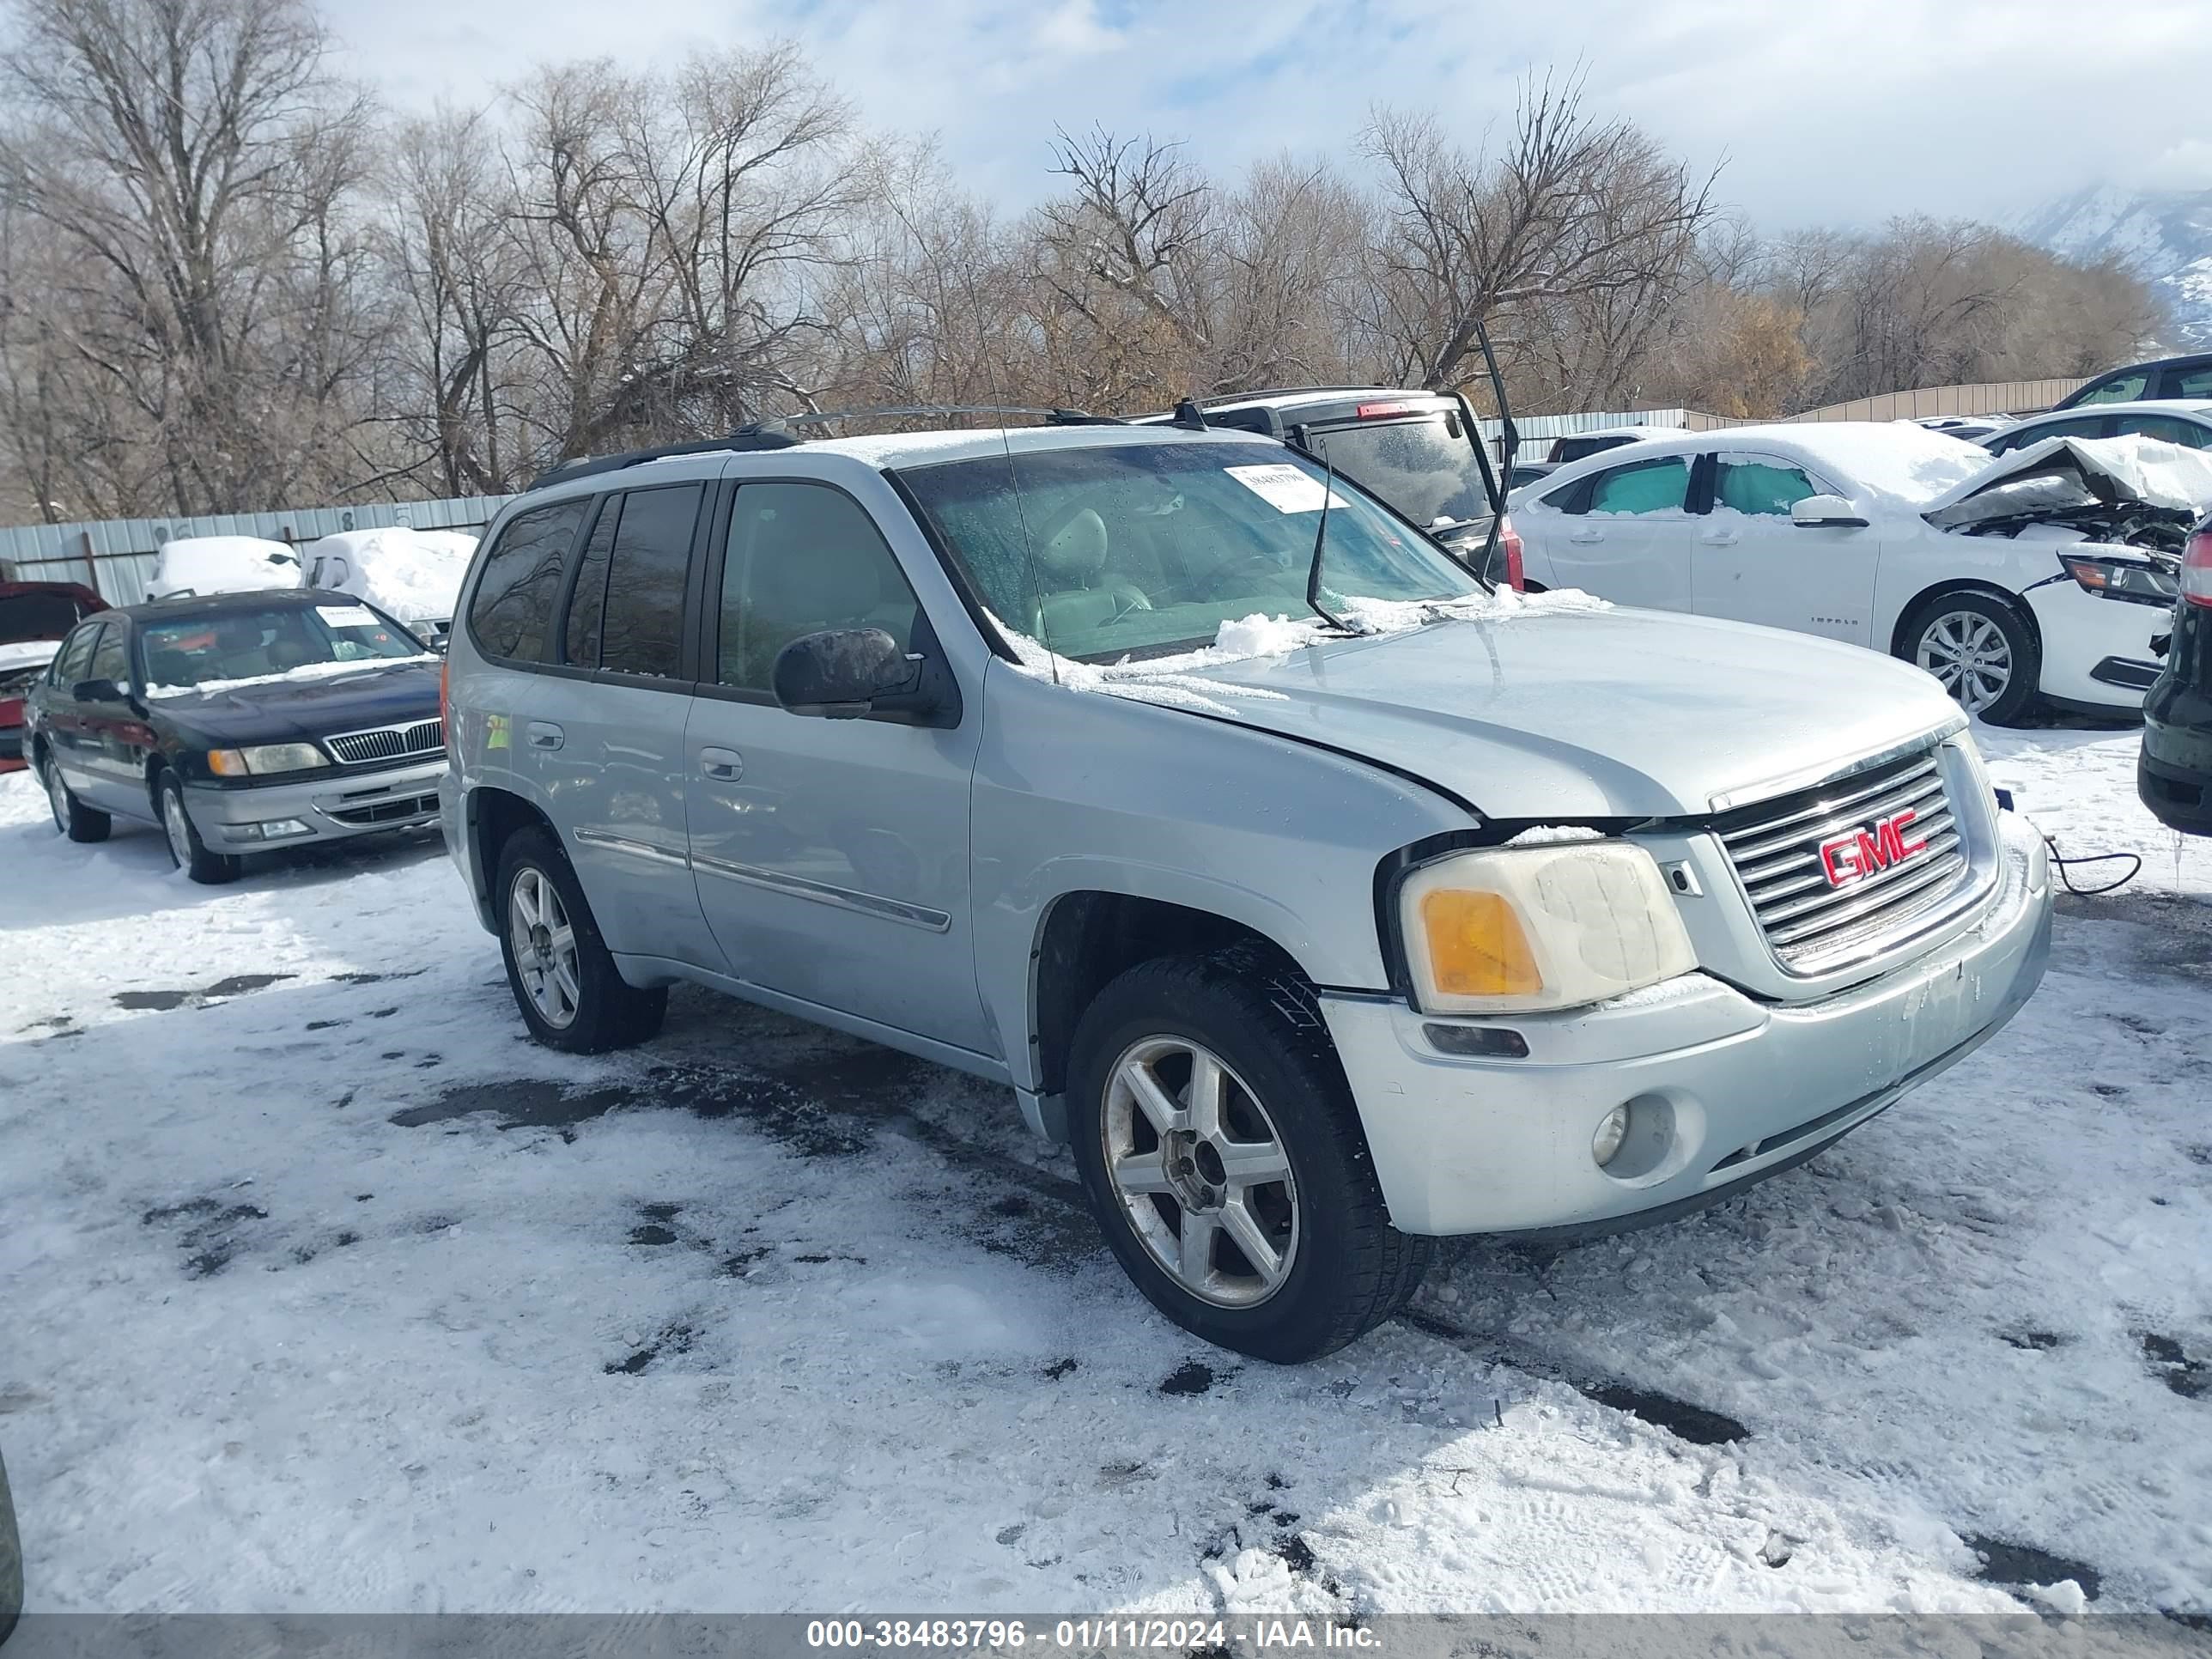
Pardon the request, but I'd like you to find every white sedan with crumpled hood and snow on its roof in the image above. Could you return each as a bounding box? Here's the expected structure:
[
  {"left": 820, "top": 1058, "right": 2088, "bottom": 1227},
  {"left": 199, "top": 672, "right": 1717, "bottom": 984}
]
[{"left": 1513, "top": 420, "right": 2212, "bottom": 721}]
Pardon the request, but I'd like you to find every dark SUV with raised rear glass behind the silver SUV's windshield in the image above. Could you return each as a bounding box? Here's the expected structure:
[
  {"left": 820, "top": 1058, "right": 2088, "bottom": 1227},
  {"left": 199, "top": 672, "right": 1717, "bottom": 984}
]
[{"left": 1157, "top": 387, "right": 1522, "bottom": 588}]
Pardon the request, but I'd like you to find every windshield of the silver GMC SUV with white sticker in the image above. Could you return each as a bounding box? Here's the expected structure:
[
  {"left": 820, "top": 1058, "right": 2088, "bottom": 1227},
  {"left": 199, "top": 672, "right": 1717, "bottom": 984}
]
[{"left": 898, "top": 442, "right": 1482, "bottom": 661}]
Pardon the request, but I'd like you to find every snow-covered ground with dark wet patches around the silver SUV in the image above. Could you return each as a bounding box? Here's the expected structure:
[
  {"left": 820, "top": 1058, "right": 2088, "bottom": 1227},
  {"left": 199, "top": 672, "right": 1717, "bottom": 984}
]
[{"left": 0, "top": 730, "right": 2212, "bottom": 1614}]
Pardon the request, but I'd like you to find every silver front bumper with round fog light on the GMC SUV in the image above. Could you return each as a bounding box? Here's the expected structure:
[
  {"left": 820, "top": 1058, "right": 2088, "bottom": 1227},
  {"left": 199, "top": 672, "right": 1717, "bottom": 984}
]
[{"left": 1322, "top": 817, "right": 2051, "bottom": 1234}]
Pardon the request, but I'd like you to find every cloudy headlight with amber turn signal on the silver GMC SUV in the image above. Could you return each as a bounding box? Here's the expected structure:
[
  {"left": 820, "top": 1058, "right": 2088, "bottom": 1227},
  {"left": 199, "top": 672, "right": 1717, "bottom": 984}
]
[{"left": 1398, "top": 841, "right": 1697, "bottom": 1013}]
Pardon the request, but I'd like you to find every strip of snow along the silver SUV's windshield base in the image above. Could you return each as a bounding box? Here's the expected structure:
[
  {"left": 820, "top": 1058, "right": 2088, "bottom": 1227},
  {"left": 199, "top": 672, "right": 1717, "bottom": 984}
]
[{"left": 1004, "top": 588, "right": 1610, "bottom": 714}]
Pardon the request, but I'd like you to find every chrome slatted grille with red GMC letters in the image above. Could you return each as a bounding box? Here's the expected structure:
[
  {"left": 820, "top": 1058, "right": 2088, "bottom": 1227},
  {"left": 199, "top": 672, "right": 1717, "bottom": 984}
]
[{"left": 1712, "top": 750, "right": 1973, "bottom": 973}]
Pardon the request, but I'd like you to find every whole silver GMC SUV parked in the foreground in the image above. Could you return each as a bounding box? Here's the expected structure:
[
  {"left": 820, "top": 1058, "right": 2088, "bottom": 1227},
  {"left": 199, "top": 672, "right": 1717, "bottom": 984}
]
[{"left": 441, "top": 422, "right": 2051, "bottom": 1360}]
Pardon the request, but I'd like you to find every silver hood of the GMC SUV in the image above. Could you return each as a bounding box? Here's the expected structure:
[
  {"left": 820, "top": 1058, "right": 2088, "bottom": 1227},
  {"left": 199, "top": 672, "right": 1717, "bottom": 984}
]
[{"left": 1206, "top": 608, "right": 1960, "bottom": 821}]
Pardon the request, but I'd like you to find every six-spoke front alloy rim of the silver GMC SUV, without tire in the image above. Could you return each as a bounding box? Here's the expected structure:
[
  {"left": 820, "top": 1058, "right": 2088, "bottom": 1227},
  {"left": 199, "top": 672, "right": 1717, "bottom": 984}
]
[{"left": 1099, "top": 1037, "right": 1298, "bottom": 1307}]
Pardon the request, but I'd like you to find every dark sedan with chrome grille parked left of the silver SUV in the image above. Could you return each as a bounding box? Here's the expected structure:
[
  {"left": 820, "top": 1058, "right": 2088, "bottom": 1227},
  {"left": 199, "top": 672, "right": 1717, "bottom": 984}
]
[{"left": 27, "top": 588, "right": 445, "bottom": 883}]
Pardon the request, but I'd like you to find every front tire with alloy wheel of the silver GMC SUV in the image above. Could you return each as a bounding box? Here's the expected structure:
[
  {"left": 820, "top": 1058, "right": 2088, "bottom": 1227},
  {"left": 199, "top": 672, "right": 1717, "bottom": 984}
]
[{"left": 1068, "top": 953, "right": 1436, "bottom": 1364}]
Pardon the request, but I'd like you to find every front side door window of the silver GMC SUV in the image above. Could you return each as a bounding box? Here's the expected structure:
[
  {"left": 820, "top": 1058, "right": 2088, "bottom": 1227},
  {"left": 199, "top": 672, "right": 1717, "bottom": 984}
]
[{"left": 717, "top": 484, "right": 921, "bottom": 692}]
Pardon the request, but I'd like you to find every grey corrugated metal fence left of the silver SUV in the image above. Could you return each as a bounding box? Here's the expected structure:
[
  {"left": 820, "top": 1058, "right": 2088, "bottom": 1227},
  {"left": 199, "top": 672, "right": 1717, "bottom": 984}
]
[{"left": 0, "top": 495, "right": 514, "bottom": 604}]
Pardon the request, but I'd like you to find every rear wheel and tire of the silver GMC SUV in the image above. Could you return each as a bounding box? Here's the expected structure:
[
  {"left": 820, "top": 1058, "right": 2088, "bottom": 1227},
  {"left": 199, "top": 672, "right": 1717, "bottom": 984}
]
[{"left": 495, "top": 830, "right": 668, "bottom": 1055}]
